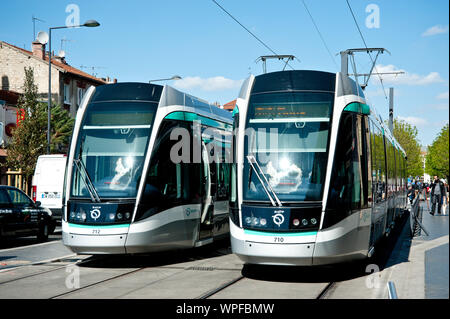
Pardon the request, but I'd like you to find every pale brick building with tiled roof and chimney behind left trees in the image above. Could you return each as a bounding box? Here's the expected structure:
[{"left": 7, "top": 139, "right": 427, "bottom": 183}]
[{"left": 0, "top": 41, "right": 109, "bottom": 184}]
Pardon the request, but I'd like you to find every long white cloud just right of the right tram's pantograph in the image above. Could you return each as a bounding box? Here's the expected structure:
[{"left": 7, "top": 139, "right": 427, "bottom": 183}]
[{"left": 372, "top": 64, "right": 445, "bottom": 85}]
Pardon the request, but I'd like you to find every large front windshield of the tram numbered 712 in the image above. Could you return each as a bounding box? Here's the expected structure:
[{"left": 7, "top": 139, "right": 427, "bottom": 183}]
[{"left": 71, "top": 102, "right": 157, "bottom": 198}]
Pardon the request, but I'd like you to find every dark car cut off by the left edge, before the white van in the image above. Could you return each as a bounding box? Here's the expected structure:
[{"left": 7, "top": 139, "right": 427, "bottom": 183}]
[{"left": 0, "top": 186, "right": 56, "bottom": 241}]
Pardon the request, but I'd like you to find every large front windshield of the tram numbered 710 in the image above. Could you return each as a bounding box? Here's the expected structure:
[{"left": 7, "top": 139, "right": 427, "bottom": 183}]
[{"left": 243, "top": 92, "right": 334, "bottom": 202}]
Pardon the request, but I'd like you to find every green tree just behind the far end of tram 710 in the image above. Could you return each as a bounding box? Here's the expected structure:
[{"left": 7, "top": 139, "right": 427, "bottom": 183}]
[{"left": 394, "top": 118, "right": 423, "bottom": 176}]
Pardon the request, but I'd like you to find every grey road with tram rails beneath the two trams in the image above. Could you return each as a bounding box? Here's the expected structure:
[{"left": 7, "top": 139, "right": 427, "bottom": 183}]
[{"left": 0, "top": 212, "right": 442, "bottom": 302}]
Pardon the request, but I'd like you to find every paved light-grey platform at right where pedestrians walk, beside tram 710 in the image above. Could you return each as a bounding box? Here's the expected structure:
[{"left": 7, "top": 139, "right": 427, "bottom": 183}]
[{"left": 384, "top": 201, "right": 449, "bottom": 299}]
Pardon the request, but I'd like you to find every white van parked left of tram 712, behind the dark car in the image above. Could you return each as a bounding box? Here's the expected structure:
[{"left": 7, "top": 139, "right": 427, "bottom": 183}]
[{"left": 32, "top": 154, "right": 67, "bottom": 222}]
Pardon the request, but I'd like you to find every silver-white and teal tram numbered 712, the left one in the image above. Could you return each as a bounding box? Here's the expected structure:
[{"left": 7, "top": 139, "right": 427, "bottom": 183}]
[{"left": 62, "top": 83, "right": 232, "bottom": 254}]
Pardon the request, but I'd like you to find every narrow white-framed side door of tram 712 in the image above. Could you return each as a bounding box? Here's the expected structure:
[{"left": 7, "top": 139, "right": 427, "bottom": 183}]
[{"left": 199, "top": 142, "right": 216, "bottom": 240}]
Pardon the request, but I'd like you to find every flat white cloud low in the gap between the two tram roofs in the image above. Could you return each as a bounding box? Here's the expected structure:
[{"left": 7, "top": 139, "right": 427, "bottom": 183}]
[{"left": 174, "top": 76, "right": 243, "bottom": 91}]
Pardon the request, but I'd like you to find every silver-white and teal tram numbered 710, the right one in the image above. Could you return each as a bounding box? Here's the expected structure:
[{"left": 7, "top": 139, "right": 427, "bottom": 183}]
[{"left": 230, "top": 70, "right": 406, "bottom": 265}]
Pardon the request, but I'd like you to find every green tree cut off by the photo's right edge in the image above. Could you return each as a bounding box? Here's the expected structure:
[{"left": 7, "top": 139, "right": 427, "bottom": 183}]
[{"left": 425, "top": 123, "right": 449, "bottom": 181}]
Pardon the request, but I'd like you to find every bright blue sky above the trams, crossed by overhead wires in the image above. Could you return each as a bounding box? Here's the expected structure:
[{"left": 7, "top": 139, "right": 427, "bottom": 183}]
[{"left": 0, "top": 0, "right": 449, "bottom": 145}]
